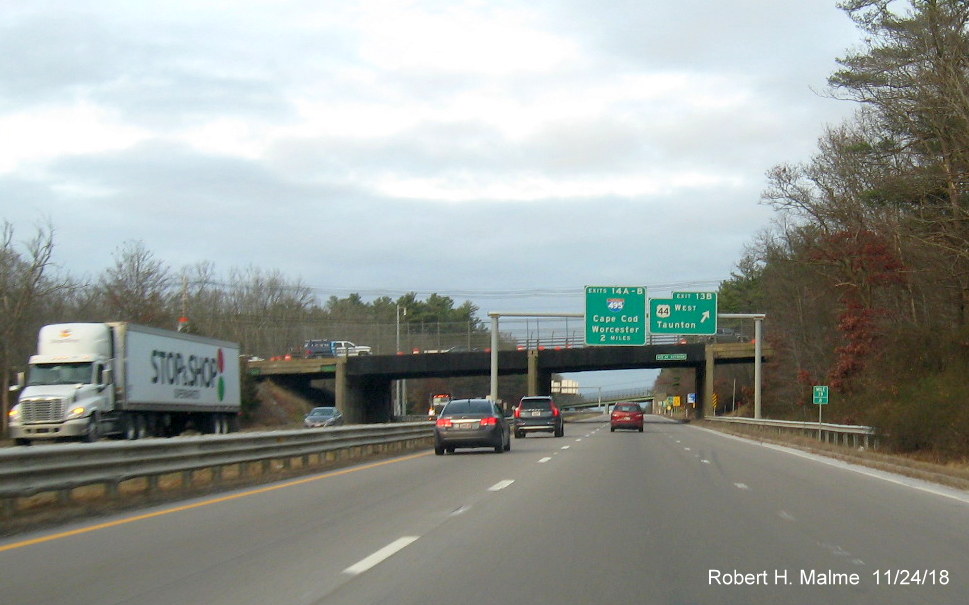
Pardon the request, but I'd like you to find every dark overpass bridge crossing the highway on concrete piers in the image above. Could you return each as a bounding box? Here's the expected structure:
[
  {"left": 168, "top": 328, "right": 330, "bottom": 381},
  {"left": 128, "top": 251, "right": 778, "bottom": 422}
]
[{"left": 248, "top": 343, "right": 769, "bottom": 423}]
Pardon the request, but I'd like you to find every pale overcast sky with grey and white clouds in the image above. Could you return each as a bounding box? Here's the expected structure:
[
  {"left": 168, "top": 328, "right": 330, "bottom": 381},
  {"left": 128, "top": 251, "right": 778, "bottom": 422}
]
[{"left": 0, "top": 0, "right": 859, "bottom": 386}]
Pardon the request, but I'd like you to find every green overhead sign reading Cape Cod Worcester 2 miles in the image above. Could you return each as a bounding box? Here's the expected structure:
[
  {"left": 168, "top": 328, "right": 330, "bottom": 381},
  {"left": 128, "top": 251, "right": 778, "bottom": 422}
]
[{"left": 585, "top": 286, "right": 646, "bottom": 346}]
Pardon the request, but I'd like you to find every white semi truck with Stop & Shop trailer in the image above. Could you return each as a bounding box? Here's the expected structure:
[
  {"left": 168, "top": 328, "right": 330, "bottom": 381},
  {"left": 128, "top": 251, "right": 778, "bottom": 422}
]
[{"left": 9, "top": 322, "right": 240, "bottom": 445}]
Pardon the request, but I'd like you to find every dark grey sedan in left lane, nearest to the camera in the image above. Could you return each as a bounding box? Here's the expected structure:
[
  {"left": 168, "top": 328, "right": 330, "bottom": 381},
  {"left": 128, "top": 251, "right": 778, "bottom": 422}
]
[{"left": 434, "top": 399, "right": 511, "bottom": 456}]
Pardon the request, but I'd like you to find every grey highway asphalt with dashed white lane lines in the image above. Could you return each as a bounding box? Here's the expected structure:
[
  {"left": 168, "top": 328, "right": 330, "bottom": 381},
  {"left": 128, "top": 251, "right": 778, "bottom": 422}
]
[{"left": 0, "top": 417, "right": 969, "bottom": 605}]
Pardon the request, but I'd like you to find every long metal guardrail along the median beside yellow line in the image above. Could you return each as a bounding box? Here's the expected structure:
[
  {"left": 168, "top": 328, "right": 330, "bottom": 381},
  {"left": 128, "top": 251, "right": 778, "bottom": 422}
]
[{"left": 0, "top": 422, "right": 433, "bottom": 502}]
